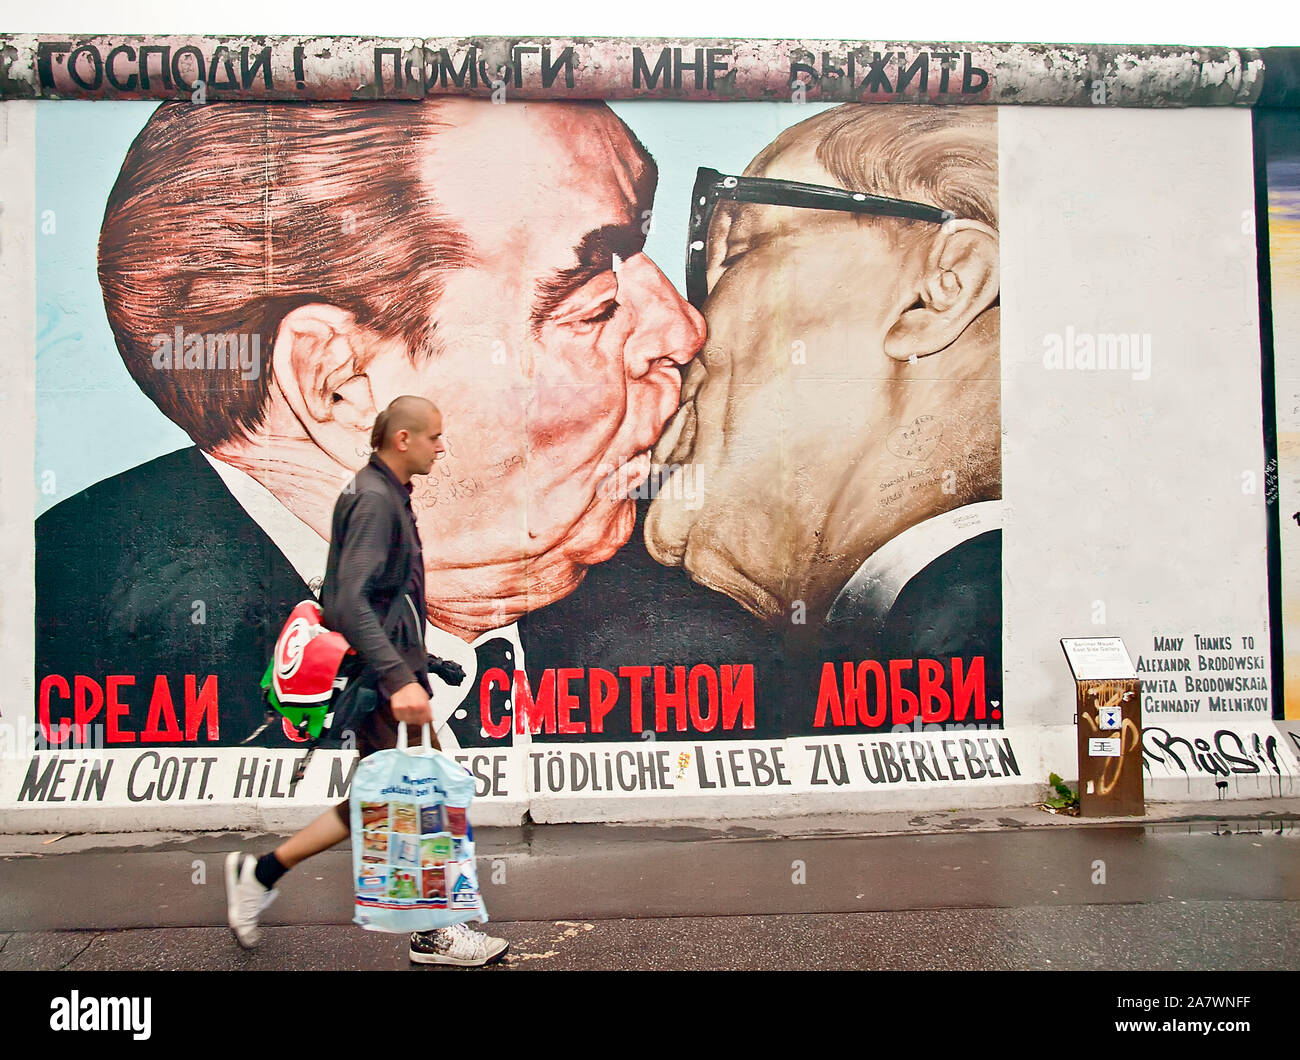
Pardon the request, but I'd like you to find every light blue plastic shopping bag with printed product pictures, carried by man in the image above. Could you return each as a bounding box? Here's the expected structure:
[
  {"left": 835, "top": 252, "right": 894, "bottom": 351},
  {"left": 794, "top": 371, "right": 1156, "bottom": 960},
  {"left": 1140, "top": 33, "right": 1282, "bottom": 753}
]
[{"left": 350, "top": 724, "right": 488, "bottom": 933}]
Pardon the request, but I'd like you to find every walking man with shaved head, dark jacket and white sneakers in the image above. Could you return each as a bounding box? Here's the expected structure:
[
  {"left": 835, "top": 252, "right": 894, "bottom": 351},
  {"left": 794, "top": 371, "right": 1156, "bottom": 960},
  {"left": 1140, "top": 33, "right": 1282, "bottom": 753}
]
[{"left": 226, "top": 395, "right": 508, "bottom": 966}]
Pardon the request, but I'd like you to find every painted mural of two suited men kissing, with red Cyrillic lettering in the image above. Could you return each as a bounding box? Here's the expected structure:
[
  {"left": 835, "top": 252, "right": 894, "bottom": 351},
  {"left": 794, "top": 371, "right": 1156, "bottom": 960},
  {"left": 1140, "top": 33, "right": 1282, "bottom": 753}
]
[{"left": 36, "top": 99, "right": 1002, "bottom": 747}]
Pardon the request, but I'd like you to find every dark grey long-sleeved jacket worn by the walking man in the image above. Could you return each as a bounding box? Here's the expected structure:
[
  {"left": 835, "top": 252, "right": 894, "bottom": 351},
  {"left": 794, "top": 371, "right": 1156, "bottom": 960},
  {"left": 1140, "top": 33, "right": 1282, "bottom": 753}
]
[{"left": 321, "top": 457, "right": 428, "bottom": 697}]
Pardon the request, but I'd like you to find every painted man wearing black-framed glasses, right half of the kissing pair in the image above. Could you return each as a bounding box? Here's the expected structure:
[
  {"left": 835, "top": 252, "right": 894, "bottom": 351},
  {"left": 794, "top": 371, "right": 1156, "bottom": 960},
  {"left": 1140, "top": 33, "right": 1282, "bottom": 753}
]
[{"left": 646, "top": 104, "right": 1001, "bottom": 681}]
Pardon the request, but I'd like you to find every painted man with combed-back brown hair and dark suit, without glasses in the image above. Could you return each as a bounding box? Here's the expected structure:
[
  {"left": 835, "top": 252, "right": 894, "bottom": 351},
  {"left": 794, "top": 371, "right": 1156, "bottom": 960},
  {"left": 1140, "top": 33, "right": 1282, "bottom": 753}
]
[{"left": 36, "top": 100, "right": 703, "bottom": 744}]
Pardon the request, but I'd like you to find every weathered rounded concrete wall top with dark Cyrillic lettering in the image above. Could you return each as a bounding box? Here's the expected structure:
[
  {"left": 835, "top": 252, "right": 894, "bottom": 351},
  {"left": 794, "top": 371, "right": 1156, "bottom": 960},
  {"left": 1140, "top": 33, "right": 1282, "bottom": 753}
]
[{"left": 0, "top": 34, "right": 1300, "bottom": 107}]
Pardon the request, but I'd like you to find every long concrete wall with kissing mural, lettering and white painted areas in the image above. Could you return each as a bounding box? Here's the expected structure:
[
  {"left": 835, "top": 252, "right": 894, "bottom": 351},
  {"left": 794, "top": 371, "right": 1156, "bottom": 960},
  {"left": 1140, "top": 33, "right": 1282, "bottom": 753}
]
[{"left": 0, "top": 35, "right": 1300, "bottom": 831}]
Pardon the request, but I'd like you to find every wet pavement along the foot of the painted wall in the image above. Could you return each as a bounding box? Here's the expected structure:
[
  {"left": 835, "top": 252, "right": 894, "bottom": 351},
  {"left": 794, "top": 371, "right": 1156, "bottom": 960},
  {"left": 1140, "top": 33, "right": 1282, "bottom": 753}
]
[{"left": 0, "top": 799, "right": 1300, "bottom": 969}]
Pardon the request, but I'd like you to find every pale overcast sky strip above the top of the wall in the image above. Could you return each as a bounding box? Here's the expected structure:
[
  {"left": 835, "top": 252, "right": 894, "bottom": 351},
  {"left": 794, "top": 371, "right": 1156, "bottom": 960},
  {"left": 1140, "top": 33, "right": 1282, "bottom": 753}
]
[{"left": 0, "top": 0, "right": 1300, "bottom": 47}]
